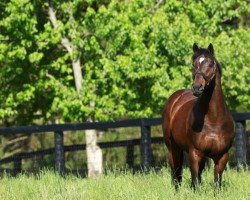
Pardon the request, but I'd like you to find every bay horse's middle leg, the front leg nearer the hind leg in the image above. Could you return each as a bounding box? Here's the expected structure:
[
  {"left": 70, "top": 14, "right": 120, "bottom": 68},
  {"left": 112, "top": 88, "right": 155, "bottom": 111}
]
[{"left": 188, "top": 149, "right": 204, "bottom": 191}]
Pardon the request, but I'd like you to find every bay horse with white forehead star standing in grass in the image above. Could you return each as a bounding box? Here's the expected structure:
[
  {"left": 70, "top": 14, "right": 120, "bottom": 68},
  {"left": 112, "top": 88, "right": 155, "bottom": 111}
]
[{"left": 162, "top": 43, "right": 234, "bottom": 190}]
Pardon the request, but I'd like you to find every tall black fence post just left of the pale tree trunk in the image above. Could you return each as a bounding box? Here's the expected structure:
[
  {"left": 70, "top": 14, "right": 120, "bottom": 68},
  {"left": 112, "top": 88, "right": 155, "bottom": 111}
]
[{"left": 55, "top": 131, "right": 64, "bottom": 175}]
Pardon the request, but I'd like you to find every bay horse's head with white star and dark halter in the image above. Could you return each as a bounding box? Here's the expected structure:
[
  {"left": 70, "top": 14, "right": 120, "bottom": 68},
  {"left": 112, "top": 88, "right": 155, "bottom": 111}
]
[{"left": 192, "top": 43, "right": 217, "bottom": 97}]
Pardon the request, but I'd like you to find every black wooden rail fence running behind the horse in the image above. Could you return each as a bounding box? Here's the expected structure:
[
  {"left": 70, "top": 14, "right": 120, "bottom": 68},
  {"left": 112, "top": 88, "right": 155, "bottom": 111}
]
[{"left": 0, "top": 113, "right": 250, "bottom": 174}]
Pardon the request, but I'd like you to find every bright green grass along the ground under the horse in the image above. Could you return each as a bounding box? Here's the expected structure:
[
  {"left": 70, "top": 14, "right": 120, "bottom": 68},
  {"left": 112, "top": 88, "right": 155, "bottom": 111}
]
[{"left": 0, "top": 168, "right": 250, "bottom": 200}]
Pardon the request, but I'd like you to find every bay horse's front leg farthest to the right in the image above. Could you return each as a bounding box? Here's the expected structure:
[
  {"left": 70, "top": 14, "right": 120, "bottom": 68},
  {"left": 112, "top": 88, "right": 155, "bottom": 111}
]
[{"left": 214, "top": 152, "right": 229, "bottom": 188}]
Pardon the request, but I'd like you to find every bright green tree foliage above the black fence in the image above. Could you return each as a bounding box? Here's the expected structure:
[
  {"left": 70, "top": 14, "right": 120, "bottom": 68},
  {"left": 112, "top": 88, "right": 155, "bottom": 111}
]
[{"left": 0, "top": 0, "right": 250, "bottom": 124}]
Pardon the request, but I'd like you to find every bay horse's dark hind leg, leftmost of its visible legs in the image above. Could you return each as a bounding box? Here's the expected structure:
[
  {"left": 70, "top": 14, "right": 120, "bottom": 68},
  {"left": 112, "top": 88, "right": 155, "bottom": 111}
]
[{"left": 166, "top": 139, "right": 183, "bottom": 189}]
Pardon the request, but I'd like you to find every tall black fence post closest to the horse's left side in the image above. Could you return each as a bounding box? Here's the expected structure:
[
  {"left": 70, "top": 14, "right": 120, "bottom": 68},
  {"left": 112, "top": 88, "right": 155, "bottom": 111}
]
[{"left": 141, "top": 119, "right": 152, "bottom": 174}]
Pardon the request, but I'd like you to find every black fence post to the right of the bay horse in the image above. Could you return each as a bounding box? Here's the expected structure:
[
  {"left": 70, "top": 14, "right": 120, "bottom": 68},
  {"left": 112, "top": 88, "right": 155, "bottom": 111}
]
[{"left": 235, "top": 121, "right": 247, "bottom": 165}]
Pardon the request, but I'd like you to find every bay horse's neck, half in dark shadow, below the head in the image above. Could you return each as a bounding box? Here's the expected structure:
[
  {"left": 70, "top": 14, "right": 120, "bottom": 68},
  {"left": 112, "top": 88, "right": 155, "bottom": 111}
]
[{"left": 199, "top": 72, "right": 226, "bottom": 123}]
